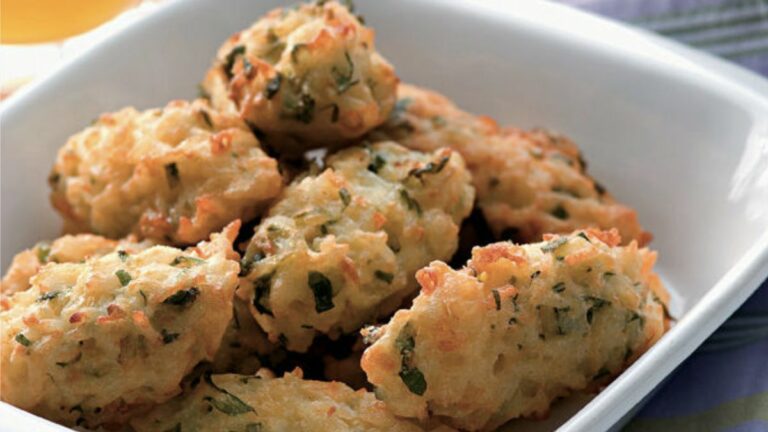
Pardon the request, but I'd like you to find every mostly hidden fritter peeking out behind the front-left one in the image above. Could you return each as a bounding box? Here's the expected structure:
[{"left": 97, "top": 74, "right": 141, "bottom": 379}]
[{"left": 0, "top": 234, "right": 150, "bottom": 295}]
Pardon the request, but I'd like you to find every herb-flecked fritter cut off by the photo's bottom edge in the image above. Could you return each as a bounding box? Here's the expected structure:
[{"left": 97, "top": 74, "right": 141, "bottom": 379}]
[{"left": 131, "top": 373, "right": 421, "bottom": 432}]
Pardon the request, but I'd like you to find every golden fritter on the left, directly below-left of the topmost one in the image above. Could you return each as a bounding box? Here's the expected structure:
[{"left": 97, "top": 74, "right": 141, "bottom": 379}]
[{"left": 49, "top": 100, "right": 283, "bottom": 245}]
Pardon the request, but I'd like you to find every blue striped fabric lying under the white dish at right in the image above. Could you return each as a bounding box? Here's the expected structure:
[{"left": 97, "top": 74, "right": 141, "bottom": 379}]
[{"left": 560, "top": 0, "right": 768, "bottom": 432}]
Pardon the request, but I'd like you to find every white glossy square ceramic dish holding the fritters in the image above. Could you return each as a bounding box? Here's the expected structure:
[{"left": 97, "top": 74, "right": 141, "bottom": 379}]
[{"left": 0, "top": 0, "right": 768, "bottom": 432}]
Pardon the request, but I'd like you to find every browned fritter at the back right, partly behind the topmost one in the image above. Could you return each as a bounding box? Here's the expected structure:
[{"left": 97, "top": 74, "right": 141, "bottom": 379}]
[{"left": 372, "top": 85, "right": 651, "bottom": 246}]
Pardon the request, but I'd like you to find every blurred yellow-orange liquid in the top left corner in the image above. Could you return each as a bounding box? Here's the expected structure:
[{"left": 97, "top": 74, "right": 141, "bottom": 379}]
[{"left": 0, "top": 0, "right": 138, "bottom": 44}]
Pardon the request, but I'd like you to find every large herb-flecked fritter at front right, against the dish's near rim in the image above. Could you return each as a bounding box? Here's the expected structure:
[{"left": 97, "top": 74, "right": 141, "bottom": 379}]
[{"left": 362, "top": 229, "right": 668, "bottom": 430}]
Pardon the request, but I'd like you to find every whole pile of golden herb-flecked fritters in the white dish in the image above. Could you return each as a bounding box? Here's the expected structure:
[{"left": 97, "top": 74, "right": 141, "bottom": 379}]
[{"left": 0, "top": 1, "right": 669, "bottom": 432}]
